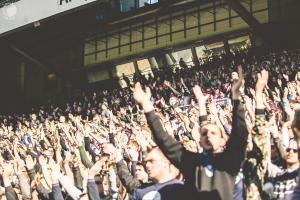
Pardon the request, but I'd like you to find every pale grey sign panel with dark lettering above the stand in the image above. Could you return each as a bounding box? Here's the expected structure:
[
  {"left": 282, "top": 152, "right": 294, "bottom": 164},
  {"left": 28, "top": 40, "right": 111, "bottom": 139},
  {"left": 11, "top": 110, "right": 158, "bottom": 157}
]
[{"left": 0, "top": 0, "right": 96, "bottom": 35}]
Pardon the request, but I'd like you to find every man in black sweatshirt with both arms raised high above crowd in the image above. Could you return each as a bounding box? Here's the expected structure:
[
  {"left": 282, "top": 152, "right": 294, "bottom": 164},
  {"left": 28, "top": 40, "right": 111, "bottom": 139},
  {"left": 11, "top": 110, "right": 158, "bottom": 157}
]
[{"left": 133, "top": 66, "right": 248, "bottom": 200}]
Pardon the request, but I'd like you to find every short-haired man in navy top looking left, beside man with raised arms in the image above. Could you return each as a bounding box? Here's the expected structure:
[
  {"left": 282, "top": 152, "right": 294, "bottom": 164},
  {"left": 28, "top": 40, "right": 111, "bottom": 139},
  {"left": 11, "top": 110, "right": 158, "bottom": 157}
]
[{"left": 117, "top": 147, "right": 183, "bottom": 200}]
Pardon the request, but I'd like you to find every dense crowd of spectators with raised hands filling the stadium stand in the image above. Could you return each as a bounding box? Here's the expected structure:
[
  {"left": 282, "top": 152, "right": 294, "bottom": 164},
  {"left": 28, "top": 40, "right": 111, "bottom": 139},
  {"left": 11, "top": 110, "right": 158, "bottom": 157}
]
[{"left": 0, "top": 47, "right": 300, "bottom": 200}]
